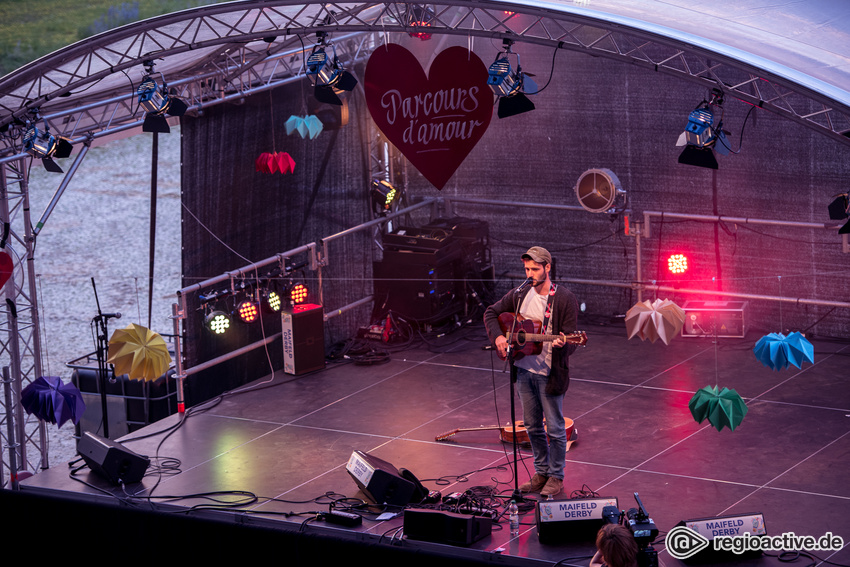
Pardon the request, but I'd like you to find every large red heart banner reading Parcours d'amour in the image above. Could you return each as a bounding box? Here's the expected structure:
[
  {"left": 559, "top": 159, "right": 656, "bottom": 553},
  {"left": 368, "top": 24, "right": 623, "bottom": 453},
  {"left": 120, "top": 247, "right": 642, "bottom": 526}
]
[{"left": 364, "top": 43, "right": 493, "bottom": 189}]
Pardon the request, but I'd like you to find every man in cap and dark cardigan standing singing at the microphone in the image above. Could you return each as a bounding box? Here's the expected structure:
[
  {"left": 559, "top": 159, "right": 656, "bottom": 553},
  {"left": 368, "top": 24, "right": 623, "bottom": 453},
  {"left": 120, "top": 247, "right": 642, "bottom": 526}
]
[{"left": 484, "top": 246, "right": 578, "bottom": 496}]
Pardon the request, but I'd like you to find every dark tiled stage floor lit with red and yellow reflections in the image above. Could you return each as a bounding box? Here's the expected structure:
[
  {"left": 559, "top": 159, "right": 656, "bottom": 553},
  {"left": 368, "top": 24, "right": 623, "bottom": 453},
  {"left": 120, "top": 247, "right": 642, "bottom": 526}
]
[{"left": 16, "top": 325, "right": 850, "bottom": 565}]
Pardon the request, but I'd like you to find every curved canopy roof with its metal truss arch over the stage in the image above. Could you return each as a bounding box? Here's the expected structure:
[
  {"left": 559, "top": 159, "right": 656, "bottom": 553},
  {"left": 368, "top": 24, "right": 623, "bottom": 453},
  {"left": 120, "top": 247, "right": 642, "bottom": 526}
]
[{"left": 0, "top": 0, "right": 850, "bottom": 161}]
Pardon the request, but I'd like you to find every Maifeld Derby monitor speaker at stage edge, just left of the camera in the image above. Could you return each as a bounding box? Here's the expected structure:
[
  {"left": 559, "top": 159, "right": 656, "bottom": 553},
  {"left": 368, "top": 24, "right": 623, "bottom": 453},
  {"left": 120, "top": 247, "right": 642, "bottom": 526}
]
[{"left": 534, "top": 497, "right": 619, "bottom": 543}]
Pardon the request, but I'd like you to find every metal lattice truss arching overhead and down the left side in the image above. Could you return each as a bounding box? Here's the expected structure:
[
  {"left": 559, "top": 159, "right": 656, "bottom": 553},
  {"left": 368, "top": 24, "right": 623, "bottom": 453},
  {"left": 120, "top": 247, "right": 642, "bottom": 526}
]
[{"left": 0, "top": 1, "right": 850, "bottom": 480}]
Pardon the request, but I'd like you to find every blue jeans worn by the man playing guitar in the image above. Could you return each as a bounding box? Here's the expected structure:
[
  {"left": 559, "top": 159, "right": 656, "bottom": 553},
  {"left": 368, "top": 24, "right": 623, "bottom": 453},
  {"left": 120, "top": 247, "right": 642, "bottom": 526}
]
[{"left": 516, "top": 368, "right": 567, "bottom": 480}]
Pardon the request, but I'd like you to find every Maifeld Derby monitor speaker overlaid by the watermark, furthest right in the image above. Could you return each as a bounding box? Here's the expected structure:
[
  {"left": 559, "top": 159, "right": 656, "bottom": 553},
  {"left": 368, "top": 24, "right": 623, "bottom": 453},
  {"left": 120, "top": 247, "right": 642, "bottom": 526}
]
[{"left": 666, "top": 513, "right": 767, "bottom": 565}]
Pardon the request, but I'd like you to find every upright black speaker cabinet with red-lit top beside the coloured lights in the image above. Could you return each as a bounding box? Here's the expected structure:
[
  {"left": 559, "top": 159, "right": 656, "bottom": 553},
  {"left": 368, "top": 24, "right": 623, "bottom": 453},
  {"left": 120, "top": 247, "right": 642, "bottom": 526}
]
[{"left": 281, "top": 303, "right": 325, "bottom": 375}]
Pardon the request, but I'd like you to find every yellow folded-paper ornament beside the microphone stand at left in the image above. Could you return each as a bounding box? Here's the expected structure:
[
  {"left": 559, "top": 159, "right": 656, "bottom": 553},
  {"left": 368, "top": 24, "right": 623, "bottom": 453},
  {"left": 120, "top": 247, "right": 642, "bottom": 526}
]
[{"left": 106, "top": 323, "right": 171, "bottom": 381}]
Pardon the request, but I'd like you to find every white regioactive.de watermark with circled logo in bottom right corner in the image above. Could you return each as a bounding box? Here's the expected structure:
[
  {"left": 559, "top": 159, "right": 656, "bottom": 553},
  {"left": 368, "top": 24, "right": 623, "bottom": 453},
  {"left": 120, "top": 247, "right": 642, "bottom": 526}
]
[{"left": 664, "top": 526, "right": 844, "bottom": 559}]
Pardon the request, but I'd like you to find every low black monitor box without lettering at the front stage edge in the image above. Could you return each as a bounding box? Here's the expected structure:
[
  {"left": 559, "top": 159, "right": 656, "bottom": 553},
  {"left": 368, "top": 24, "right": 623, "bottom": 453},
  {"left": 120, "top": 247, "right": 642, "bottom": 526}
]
[{"left": 404, "top": 508, "right": 493, "bottom": 545}]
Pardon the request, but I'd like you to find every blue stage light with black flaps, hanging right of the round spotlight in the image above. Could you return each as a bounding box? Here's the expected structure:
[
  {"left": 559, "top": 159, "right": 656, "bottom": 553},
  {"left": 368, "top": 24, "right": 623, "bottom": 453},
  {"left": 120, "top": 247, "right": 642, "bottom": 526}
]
[{"left": 676, "top": 89, "right": 730, "bottom": 169}]
